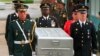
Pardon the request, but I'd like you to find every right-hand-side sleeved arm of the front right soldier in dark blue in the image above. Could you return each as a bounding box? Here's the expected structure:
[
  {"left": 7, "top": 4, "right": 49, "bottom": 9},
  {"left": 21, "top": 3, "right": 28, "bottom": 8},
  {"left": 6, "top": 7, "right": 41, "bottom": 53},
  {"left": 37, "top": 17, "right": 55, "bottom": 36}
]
[{"left": 91, "top": 23, "right": 97, "bottom": 53}]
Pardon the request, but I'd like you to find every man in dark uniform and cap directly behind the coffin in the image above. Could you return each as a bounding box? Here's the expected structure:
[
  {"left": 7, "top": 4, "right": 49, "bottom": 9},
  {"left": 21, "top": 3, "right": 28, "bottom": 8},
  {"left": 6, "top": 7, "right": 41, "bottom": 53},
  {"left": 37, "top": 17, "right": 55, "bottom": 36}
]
[{"left": 36, "top": 3, "right": 59, "bottom": 27}]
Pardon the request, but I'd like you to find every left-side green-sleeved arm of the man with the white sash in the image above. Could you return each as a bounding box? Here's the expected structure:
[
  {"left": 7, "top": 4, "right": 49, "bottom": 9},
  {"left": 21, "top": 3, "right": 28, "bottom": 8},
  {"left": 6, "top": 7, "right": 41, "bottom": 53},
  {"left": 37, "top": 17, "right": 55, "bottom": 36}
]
[{"left": 7, "top": 23, "right": 14, "bottom": 55}]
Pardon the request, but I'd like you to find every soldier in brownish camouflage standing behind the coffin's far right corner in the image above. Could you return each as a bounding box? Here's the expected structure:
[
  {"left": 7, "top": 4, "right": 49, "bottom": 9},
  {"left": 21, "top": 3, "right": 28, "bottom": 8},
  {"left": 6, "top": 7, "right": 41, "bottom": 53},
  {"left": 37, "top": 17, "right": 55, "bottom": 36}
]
[{"left": 51, "top": 2, "right": 67, "bottom": 28}]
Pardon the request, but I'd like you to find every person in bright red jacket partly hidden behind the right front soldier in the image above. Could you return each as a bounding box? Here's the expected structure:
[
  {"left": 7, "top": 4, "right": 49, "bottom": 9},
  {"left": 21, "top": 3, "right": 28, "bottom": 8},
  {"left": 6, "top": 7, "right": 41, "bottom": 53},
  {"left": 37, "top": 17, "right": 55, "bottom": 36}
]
[{"left": 64, "top": 6, "right": 78, "bottom": 35}]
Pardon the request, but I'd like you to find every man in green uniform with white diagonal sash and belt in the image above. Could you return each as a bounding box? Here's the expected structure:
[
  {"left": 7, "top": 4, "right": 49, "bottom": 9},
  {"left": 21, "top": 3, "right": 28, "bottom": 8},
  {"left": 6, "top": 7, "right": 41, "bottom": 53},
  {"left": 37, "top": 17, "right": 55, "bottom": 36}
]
[{"left": 7, "top": 5, "right": 36, "bottom": 56}]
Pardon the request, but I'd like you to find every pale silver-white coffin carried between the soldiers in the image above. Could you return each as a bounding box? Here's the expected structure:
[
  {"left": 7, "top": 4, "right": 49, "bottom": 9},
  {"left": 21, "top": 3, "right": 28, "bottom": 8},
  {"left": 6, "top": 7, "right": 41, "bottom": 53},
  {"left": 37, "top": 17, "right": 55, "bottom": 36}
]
[{"left": 35, "top": 28, "right": 73, "bottom": 56}]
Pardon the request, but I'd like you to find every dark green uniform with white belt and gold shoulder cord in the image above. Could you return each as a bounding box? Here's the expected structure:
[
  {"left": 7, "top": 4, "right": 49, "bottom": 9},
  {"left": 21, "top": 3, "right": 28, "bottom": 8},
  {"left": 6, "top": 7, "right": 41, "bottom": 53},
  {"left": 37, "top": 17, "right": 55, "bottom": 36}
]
[{"left": 8, "top": 19, "right": 35, "bottom": 56}]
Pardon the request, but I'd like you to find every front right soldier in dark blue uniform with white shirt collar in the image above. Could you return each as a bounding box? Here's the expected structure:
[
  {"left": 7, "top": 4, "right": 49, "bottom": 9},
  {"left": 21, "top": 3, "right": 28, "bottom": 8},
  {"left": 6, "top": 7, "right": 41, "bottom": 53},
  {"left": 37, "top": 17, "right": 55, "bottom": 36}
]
[{"left": 71, "top": 5, "right": 97, "bottom": 56}]
